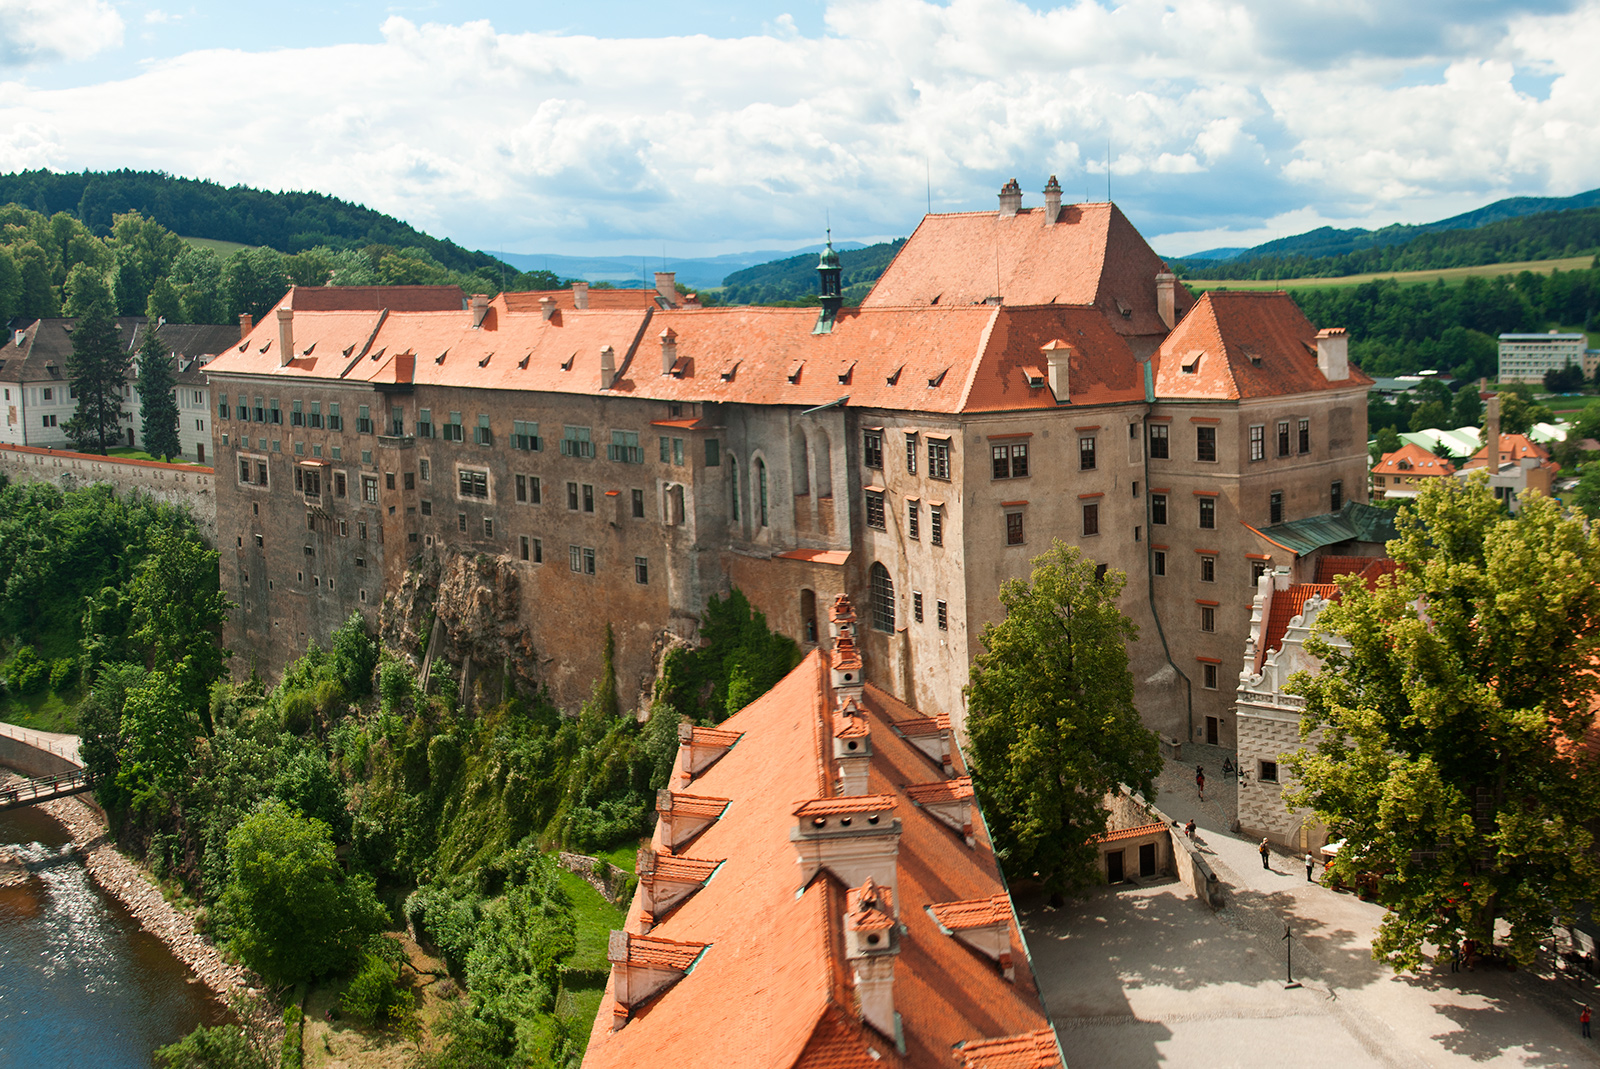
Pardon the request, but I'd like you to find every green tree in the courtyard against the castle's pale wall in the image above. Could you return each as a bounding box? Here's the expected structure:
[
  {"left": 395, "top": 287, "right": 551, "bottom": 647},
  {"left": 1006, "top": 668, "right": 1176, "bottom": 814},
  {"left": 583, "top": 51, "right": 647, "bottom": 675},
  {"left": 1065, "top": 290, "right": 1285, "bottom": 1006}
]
[{"left": 966, "top": 539, "right": 1162, "bottom": 891}]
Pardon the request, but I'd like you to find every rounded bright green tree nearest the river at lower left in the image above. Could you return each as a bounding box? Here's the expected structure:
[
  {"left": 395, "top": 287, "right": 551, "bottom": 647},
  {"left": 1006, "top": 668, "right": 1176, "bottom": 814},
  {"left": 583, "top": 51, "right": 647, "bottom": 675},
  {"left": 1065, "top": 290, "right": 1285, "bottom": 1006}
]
[{"left": 222, "top": 799, "right": 389, "bottom": 984}]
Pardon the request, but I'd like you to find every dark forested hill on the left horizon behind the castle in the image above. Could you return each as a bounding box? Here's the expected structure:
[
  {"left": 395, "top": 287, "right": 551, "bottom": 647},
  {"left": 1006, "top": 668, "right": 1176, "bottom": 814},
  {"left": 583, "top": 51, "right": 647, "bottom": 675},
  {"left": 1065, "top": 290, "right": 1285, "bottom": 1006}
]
[{"left": 0, "top": 170, "right": 517, "bottom": 277}]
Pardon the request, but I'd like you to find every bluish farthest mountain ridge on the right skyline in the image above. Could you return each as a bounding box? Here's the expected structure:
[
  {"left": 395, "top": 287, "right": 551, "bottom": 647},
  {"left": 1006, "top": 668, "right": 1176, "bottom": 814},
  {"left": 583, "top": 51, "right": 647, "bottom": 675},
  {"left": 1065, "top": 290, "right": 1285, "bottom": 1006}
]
[{"left": 1166, "top": 189, "right": 1600, "bottom": 278}]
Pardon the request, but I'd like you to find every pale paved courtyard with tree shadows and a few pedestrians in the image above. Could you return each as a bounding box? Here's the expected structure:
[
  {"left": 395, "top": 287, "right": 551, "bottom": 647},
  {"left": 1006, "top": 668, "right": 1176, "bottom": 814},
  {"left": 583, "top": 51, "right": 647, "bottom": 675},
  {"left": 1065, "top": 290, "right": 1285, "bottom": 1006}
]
[{"left": 1018, "top": 746, "right": 1600, "bottom": 1069}]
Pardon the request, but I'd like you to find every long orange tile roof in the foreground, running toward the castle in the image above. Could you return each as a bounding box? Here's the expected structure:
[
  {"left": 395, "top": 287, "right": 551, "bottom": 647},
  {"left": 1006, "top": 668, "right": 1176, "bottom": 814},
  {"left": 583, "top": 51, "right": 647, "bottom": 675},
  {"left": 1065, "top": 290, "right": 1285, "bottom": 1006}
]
[{"left": 584, "top": 651, "right": 1058, "bottom": 1069}]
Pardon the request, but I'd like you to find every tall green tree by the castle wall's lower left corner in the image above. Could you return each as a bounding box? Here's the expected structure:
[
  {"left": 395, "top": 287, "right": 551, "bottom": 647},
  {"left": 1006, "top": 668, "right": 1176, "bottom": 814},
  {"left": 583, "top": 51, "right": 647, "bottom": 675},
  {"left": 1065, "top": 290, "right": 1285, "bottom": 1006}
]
[{"left": 128, "top": 530, "right": 230, "bottom": 733}]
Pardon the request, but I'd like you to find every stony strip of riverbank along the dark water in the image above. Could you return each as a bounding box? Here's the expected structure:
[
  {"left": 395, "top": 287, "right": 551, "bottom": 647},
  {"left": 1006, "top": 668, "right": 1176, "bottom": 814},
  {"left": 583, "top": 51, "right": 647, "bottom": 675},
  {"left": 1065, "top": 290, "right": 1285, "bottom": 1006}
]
[{"left": 0, "top": 770, "right": 283, "bottom": 1048}]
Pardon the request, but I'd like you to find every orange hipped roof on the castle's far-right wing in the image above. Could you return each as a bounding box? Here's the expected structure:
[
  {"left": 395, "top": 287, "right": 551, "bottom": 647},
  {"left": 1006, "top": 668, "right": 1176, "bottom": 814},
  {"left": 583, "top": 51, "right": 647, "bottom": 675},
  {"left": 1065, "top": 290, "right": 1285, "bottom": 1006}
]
[{"left": 1155, "top": 291, "right": 1373, "bottom": 400}]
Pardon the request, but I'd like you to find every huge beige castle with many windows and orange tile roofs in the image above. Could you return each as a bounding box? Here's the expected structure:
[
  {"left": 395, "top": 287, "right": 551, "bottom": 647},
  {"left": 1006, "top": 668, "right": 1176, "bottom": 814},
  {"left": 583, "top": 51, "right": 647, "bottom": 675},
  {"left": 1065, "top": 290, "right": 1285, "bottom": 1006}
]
[{"left": 208, "top": 182, "right": 1370, "bottom": 744}]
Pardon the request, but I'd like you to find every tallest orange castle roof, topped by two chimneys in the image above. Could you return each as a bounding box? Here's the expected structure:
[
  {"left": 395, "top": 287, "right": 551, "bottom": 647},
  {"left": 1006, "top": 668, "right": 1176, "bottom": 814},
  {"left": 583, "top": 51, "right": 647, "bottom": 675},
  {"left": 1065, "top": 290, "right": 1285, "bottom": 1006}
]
[{"left": 862, "top": 203, "right": 1194, "bottom": 334}]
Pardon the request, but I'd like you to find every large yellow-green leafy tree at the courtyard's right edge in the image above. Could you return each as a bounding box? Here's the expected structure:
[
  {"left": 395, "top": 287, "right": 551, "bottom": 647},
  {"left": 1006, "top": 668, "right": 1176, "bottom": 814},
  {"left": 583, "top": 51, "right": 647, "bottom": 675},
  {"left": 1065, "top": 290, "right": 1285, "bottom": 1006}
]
[{"left": 1285, "top": 475, "right": 1600, "bottom": 968}]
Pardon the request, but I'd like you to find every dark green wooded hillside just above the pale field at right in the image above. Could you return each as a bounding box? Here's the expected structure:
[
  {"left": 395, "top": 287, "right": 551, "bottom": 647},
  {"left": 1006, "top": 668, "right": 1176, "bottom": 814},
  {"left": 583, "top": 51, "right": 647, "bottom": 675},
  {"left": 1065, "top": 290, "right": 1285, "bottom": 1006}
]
[{"left": 1173, "top": 208, "right": 1600, "bottom": 278}]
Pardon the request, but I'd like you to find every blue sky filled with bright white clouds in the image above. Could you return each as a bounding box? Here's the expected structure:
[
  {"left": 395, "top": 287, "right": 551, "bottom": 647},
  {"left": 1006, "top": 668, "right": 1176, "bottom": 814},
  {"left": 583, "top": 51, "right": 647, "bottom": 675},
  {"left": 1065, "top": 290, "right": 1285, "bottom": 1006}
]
[{"left": 0, "top": 0, "right": 1600, "bottom": 256}]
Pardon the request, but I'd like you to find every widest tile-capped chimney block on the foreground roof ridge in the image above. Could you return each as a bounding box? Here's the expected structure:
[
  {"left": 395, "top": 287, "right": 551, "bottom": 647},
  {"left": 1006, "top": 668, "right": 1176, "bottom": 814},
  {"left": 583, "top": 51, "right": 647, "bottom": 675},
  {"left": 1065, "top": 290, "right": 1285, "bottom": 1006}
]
[{"left": 790, "top": 794, "right": 901, "bottom": 908}]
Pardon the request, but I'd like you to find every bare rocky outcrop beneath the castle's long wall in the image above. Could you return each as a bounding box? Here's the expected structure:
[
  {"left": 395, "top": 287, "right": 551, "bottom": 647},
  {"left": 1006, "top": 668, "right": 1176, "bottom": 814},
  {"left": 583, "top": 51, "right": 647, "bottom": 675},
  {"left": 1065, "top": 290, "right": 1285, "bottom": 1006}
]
[{"left": 379, "top": 551, "right": 539, "bottom": 699}]
